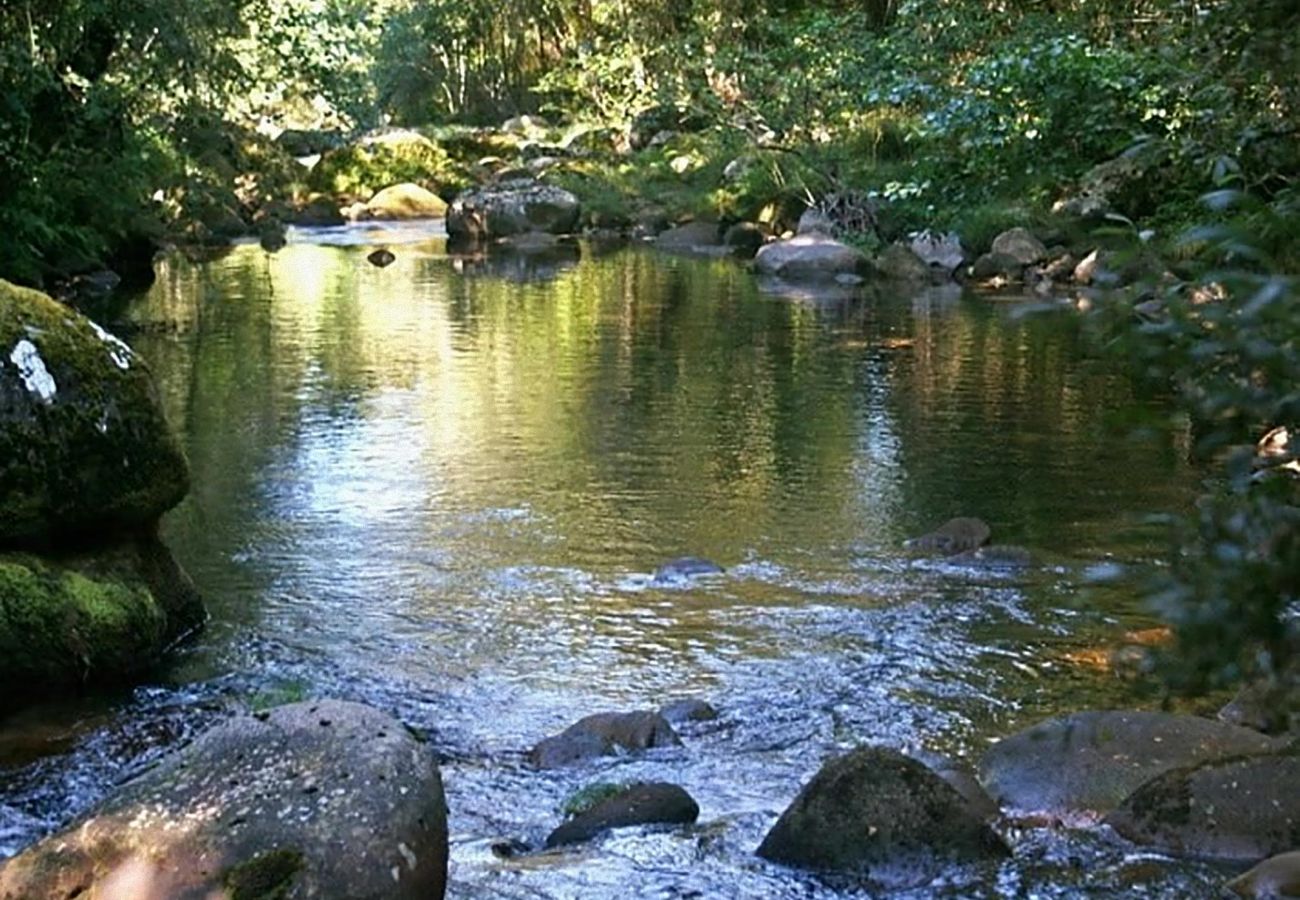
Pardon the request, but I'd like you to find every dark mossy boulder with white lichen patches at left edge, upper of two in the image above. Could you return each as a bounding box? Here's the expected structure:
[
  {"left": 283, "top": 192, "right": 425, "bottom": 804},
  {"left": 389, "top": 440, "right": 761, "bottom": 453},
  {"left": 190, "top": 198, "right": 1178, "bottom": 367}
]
[{"left": 0, "top": 281, "right": 189, "bottom": 546}]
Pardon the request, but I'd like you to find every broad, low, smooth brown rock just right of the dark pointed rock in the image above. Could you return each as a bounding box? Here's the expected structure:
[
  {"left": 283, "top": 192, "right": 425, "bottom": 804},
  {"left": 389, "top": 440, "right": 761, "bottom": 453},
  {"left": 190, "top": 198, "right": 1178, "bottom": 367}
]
[{"left": 979, "top": 711, "right": 1278, "bottom": 819}]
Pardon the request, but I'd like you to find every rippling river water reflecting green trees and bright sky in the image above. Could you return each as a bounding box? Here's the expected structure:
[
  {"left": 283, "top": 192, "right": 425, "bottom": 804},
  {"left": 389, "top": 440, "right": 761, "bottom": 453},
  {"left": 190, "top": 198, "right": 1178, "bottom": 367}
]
[{"left": 0, "top": 226, "right": 1237, "bottom": 897}]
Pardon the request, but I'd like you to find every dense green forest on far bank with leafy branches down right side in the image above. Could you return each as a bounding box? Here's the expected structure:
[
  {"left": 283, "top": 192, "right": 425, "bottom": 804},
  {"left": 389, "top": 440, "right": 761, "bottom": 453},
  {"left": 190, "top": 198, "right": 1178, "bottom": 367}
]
[{"left": 0, "top": 0, "right": 1300, "bottom": 684}]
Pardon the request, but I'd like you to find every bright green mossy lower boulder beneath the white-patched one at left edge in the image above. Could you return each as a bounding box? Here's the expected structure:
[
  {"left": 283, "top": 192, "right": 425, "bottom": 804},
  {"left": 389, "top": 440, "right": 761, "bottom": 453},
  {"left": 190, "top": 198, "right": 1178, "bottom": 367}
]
[{"left": 0, "top": 537, "right": 207, "bottom": 697}]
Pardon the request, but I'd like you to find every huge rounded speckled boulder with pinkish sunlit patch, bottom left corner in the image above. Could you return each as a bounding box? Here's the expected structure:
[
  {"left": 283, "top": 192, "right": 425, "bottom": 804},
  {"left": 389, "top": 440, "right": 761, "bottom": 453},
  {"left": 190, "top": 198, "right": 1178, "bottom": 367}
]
[{"left": 0, "top": 701, "right": 447, "bottom": 900}]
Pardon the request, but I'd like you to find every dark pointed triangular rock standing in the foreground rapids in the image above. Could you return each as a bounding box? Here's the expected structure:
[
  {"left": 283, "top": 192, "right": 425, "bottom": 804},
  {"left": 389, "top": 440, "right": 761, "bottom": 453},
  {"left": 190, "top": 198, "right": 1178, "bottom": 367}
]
[{"left": 758, "top": 747, "right": 1006, "bottom": 888}]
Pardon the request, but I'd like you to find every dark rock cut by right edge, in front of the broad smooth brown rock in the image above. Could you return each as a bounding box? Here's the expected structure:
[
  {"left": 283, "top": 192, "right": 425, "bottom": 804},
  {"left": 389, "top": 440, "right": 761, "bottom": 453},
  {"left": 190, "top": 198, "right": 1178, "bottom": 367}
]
[{"left": 1106, "top": 748, "right": 1300, "bottom": 862}]
